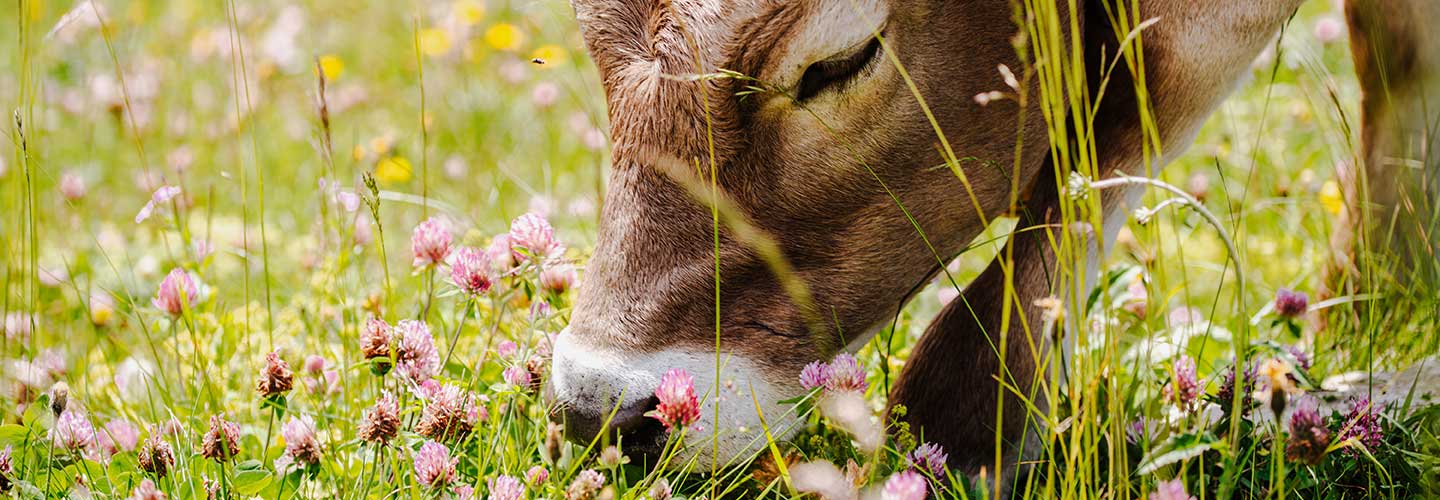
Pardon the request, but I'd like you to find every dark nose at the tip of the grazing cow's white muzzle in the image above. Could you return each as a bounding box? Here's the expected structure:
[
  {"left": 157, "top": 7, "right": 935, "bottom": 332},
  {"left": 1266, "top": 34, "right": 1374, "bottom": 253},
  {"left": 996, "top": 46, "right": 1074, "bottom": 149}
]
[{"left": 560, "top": 396, "right": 665, "bottom": 455}]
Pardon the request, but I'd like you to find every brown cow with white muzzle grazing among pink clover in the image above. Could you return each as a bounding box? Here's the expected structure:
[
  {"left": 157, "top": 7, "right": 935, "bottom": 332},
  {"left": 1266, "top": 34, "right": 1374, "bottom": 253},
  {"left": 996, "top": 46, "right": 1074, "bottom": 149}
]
[{"left": 547, "top": 0, "right": 1440, "bottom": 487}]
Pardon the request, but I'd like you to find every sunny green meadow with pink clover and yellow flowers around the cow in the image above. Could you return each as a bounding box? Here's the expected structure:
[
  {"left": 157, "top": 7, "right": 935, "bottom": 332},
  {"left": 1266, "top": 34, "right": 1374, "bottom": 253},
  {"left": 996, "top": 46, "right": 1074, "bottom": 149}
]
[{"left": 0, "top": 0, "right": 1440, "bottom": 500}]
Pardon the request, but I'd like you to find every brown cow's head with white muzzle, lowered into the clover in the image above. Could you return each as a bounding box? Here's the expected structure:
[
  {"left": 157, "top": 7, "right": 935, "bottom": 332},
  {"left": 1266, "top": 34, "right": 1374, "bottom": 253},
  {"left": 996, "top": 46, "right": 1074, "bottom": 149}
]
[{"left": 550, "top": 0, "right": 1044, "bottom": 463}]
